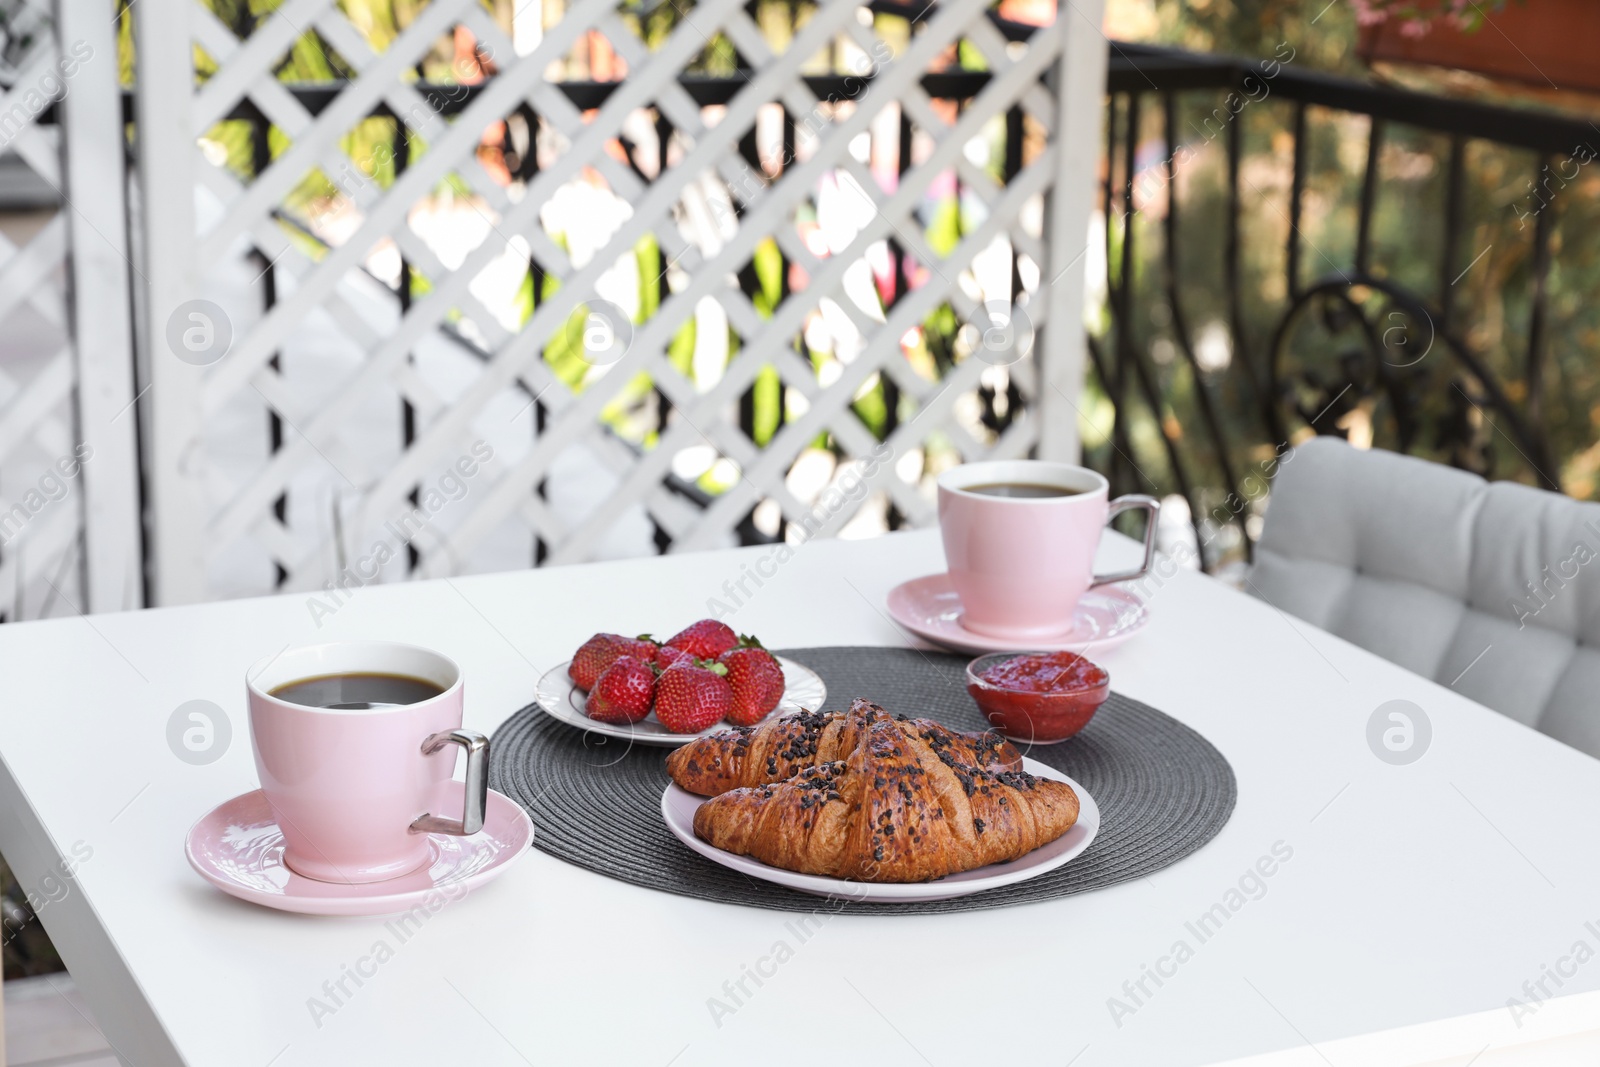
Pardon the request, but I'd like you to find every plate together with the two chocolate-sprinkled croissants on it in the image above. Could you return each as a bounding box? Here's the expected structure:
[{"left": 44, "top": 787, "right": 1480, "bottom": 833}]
[{"left": 661, "top": 697, "right": 1099, "bottom": 901}]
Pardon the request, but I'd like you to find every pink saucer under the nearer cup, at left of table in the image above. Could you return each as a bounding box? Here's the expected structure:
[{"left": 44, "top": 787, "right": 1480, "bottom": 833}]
[{"left": 184, "top": 782, "right": 533, "bottom": 915}]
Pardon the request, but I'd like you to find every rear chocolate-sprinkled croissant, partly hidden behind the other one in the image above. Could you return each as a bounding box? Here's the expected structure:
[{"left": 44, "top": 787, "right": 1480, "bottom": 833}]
[{"left": 667, "top": 697, "right": 1022, "bottom": 797}]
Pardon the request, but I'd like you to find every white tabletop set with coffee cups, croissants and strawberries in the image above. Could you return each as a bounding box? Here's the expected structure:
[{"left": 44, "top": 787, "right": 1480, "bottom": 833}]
[{"left": 0, "top": 533, "right": 1600, "bottom": 1067}]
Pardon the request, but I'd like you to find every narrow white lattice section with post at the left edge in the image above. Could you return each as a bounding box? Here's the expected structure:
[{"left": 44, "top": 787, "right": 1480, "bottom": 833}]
[{"left": 0, "top": 3, "right": 142, "bottom": 619}]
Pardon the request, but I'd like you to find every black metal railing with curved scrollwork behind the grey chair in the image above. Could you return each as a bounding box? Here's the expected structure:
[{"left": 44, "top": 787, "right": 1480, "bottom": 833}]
[{"left": 1090, "top": 45, "right": 1600, "bottom": 566}]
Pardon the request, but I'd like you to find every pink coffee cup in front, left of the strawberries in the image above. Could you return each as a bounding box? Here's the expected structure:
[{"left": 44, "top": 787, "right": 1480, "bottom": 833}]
[{"left": 245, "top": 641, "right": 488, "bottom": 885}]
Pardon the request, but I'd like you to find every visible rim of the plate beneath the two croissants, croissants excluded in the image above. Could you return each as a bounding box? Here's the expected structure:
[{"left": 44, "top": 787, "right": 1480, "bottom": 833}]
[{"left": 661, "top": 758, "right": 1099, "bottom": 904}]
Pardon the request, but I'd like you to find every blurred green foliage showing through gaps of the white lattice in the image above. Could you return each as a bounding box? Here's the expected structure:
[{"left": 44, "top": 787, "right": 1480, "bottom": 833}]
[{"left": 106, "top": 0, "right": 1003, "bottom": 493}]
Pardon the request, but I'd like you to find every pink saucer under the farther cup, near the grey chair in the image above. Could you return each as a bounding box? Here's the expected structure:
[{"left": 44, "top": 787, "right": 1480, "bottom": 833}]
[{"left": 888, "top": 574, "right": 1150, "bottom": 653}]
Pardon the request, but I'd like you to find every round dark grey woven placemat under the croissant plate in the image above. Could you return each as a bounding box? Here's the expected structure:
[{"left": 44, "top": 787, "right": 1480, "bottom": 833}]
[{"left": 490, "top": 648, "right": 1237, "bottom": 915}]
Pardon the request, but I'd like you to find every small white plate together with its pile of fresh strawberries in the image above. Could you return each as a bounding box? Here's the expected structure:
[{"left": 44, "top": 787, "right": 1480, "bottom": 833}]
[{"left": 534, "top": 619, "right": 827, "bottom": 747}]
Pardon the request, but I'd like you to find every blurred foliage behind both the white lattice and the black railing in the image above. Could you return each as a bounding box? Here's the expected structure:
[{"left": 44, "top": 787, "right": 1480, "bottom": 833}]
[{"left": 106, "top": 0, "right": 1600, "bottom": 534}]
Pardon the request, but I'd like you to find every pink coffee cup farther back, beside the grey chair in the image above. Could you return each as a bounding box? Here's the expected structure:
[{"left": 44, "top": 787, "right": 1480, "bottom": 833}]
[{"left": 939, "top": 459, "right": 1160, "bottom": 643}]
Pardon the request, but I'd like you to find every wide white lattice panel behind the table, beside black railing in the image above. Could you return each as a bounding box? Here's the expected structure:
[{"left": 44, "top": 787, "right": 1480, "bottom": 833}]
[{"left": 134, "top": 0, "right": 1104, "bottom": 603}]
